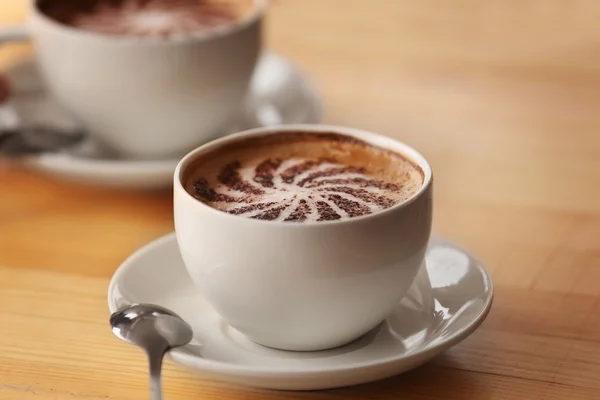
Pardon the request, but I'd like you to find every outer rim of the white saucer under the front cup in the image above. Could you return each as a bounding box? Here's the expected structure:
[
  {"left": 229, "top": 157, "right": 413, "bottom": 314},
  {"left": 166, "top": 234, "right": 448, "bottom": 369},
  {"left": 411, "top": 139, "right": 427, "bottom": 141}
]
[{"left": 108, "top": 232, "right": 494, "bottom": 378}]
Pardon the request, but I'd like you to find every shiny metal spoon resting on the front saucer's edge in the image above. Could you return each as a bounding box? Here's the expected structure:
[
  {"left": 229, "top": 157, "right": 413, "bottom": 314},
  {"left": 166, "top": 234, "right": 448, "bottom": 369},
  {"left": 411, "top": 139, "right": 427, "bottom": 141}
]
[{"left": 110, "top": 304, "right": 193, "bottom": 400}]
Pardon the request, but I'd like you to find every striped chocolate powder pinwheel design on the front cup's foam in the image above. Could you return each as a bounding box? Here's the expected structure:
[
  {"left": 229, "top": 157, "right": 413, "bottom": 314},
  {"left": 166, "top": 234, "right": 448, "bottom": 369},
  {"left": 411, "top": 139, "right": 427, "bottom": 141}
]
[{"left": 195, "top": 158, "right": 402, "bottom": 222}]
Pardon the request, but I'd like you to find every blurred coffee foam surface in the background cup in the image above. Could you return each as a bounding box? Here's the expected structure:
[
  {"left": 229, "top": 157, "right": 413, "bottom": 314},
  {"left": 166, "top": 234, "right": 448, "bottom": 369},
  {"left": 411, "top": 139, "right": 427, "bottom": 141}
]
[{"left": 41, "top": 0, "right": 253, "bottom": 36}]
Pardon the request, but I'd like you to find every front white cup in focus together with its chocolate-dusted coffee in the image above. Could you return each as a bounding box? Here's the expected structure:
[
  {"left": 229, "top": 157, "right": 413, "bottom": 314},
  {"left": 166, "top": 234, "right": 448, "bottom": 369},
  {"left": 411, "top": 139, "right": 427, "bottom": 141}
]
[{"left": 174, "top": 125, "right": 432, "bottom": 351}]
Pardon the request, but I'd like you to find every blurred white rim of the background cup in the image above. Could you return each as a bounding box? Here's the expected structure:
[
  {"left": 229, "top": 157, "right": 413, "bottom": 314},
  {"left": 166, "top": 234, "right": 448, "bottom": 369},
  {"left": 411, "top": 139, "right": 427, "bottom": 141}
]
[{"left": 28, "top": 0, "right": 270, "bottom": 46}]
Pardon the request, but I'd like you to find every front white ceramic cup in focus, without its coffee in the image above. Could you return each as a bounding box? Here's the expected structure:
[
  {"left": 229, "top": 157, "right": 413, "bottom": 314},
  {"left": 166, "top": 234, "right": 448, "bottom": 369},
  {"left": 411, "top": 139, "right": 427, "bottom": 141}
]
[{"left": 174, "top": 125, "right": 432, "bottom": 351}]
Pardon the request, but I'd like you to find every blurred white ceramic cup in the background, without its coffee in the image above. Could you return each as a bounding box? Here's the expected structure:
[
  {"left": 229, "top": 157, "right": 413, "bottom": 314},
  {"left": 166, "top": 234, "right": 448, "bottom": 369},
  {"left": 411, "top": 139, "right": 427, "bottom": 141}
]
[{"left": 0, "top": 0, "right": 266, "bottom": 158}]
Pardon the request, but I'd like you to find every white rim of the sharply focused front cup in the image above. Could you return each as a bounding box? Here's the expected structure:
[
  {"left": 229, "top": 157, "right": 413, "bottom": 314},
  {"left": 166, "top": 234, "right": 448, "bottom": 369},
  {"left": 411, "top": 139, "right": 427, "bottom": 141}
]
[{"left": 173, "top": 124, "right": 433, "bottom": 228}]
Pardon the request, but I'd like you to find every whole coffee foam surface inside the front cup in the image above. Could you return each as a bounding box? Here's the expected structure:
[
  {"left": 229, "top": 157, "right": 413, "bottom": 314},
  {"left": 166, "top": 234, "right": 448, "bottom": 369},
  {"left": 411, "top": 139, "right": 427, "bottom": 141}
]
[{"left": 184, "top": 133, "right": 423, "bottom": 222}]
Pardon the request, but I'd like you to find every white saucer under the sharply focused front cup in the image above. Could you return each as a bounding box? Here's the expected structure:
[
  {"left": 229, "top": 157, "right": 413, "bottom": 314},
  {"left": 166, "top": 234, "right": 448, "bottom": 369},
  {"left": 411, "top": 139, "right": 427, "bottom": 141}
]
[{"left": 108, "top": 234, "right": 493, "bottom": 390}]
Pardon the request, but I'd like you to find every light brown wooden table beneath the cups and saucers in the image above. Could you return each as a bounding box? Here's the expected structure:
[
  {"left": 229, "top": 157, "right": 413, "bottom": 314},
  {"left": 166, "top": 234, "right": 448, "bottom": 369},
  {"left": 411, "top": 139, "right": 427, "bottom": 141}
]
[{"left": 0, "top": 0, "right": 600, "bottom": 400}]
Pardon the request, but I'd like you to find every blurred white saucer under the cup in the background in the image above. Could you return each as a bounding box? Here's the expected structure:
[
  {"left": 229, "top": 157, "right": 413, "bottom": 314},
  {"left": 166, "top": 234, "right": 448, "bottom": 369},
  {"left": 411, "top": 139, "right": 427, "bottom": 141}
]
[{"left": 0, "top": 52, "right": 322, "bottom": 189}]
